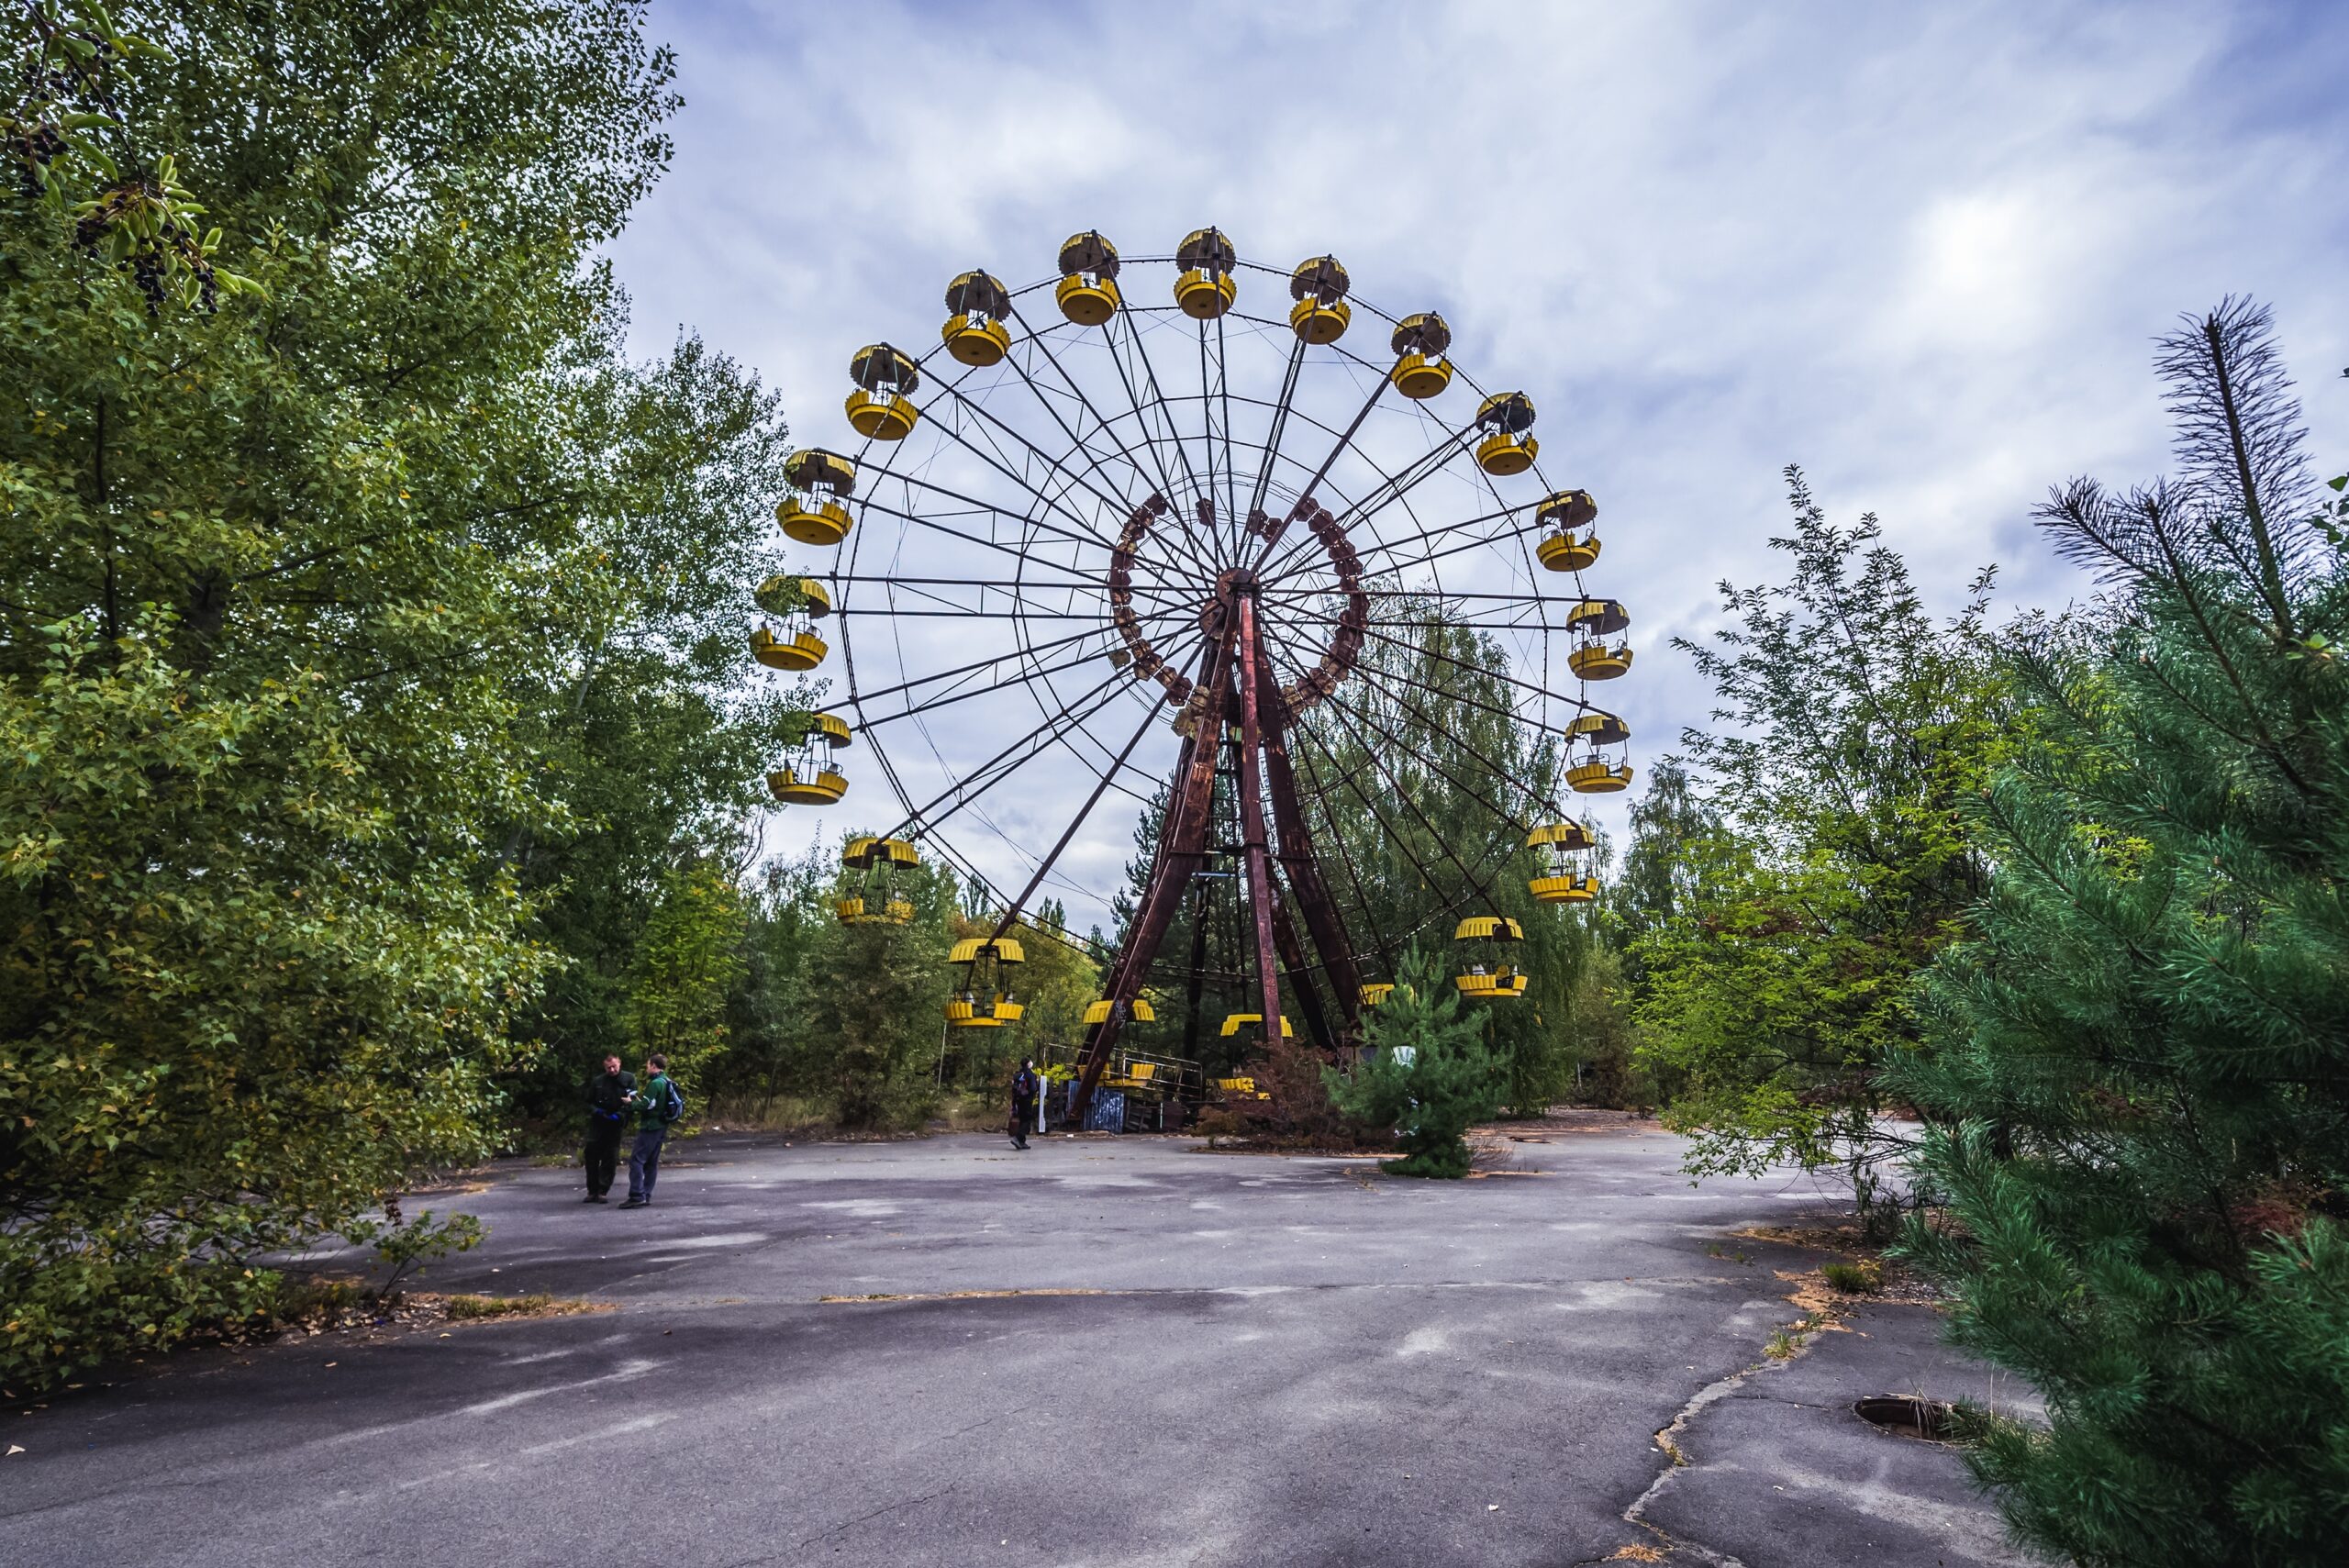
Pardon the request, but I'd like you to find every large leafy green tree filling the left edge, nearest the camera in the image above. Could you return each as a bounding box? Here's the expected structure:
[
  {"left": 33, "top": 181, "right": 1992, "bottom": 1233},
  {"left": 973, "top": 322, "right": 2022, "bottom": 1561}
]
[{"left": 0, "top": 0, "right": 674, "bottom": 1383}]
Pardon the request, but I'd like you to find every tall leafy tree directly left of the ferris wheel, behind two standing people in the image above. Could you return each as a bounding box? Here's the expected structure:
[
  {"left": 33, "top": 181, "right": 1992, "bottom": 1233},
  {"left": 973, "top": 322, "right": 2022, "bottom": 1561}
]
[{"left": 495, "top": 336, "right": 822, "bottom": 1115}]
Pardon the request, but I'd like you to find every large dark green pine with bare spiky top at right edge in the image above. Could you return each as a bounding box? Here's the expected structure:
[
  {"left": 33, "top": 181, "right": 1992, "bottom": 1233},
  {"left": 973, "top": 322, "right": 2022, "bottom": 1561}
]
[{"left": 1891, "top": 300, "right": 2349, "bottom": 1568}]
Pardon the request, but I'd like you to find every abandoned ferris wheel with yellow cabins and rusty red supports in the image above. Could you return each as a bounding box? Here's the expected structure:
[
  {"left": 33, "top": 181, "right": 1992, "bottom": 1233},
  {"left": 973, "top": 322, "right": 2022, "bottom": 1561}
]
[{"left": 751, "top": 228, "right": 1632, "bottom": 1106}]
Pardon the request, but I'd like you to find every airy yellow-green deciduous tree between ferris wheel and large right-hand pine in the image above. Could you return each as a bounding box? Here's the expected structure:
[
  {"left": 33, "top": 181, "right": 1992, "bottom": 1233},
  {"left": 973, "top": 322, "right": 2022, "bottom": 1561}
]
[{"left": 1631, "top": 470, "right": 2004, "bottom": 1225}]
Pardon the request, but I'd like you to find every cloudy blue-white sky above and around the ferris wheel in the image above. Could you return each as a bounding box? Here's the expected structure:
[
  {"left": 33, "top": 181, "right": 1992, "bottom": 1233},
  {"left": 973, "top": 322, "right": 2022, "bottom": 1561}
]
[{"left": 616, "top": 0, "right": 2349, "bottom": 922}]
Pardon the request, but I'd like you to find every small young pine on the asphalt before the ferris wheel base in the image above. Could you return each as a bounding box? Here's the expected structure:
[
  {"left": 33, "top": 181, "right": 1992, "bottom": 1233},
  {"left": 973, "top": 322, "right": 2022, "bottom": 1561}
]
[{"left": 1325, "top": 949, "right": 1508, "bottom": 1176}]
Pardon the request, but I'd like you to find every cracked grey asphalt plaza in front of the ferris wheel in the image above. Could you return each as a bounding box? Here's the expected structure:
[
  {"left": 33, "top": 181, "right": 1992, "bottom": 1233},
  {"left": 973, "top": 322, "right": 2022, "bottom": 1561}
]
[{"left": 0, "top": 1127, "right": 2025, "bottom": 1568}]
